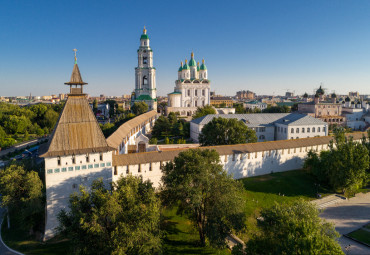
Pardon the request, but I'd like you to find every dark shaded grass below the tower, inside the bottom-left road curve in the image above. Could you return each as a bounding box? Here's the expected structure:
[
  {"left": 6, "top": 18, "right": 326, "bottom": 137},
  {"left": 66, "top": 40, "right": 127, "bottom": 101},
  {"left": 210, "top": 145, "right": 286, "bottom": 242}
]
[{"left": 1, "top": 217, "right": 71, "bottom": 255}]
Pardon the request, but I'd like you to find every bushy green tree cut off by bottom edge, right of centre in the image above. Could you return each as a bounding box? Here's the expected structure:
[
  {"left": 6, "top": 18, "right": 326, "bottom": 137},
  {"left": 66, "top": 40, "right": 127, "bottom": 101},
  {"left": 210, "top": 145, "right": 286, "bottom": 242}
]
[{"left": 246, "top": 200, "right": 343, "bottom": 255}]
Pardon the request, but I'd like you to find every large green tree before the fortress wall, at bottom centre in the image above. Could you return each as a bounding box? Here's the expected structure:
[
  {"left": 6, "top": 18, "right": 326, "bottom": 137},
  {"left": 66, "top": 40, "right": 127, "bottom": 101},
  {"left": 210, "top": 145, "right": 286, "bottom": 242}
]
[{"left": 162, "top": 149, "right": 246, "bottom": 247}]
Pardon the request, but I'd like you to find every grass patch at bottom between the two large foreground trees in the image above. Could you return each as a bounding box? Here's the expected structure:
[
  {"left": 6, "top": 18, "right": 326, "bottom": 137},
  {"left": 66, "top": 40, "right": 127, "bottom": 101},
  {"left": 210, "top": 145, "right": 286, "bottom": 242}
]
[{"left": 163, "top": 209, "right": 231, "bottom": 255}]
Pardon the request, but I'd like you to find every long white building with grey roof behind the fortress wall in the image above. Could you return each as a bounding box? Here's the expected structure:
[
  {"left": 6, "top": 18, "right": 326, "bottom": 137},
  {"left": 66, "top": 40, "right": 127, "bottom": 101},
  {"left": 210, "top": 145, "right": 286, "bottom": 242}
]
[{"left": 190, "top": 113, "right": 328, "bottom": 142}]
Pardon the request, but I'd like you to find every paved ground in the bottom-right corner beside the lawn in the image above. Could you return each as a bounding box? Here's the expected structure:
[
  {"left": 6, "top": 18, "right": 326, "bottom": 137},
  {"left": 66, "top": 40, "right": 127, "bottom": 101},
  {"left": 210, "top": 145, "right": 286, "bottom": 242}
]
[{"left": 320, "top": 192, "right": 370, "bottom": 255}]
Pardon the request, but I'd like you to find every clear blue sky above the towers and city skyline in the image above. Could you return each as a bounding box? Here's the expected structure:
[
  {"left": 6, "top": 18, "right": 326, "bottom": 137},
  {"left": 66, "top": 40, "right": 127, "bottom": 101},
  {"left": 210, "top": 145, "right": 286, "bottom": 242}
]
[{"left": 0, "top": 0, "right": 370, "bottom": 96}]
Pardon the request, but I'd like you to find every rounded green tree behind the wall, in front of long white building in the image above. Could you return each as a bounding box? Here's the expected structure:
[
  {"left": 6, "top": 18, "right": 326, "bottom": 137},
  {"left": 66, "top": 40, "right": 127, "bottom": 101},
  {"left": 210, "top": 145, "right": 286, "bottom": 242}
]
[{"left": 199, "top": 117, "right": 257, "bottom": 146}]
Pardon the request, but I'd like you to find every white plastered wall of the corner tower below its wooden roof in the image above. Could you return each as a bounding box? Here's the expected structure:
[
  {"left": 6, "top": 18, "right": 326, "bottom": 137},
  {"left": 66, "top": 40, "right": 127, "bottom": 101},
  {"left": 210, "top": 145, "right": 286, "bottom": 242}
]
[{"left": 44, "top": 152, "right": 112, "bottom": 240}]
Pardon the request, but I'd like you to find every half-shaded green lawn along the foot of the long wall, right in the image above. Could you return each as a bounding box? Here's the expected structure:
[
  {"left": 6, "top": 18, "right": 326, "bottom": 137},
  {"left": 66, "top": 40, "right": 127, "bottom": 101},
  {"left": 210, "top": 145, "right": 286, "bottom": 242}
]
[{"left": 238, "top": 170, "right": 329, "bottom": 241}]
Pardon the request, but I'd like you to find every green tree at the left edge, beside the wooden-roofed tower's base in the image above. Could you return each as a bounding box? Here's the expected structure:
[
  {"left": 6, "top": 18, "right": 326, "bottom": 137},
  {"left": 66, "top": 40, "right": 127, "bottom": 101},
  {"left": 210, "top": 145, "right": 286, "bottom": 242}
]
[{"left": 0, "top": 165, "right": 43, "bottom": 230}]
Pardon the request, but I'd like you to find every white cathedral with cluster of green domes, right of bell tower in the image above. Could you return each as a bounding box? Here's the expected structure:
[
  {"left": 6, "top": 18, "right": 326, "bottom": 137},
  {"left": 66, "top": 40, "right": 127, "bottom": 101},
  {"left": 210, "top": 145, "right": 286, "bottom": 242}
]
[{"left": 166, "top": 52, "right": 211, "bottom": 116}]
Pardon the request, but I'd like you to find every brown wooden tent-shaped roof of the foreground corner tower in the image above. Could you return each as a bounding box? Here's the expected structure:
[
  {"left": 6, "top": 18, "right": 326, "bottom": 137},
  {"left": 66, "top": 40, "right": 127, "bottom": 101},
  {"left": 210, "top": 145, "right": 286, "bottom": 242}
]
[{"left": 40, "top": 51, "right": 114, "bottom": 157}]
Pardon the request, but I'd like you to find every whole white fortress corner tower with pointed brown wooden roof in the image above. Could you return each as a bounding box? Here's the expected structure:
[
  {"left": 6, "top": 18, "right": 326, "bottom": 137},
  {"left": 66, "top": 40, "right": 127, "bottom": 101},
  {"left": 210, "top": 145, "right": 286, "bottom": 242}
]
[{"left": 40, "top": 58, "right": 114, "bottom": 240}]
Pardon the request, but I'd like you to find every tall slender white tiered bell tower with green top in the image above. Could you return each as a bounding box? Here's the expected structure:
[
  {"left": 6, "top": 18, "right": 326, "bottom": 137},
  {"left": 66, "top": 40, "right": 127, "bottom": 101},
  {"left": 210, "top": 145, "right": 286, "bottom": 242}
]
[{"left": 131, "top": 27, "right": 157, "bottom": 110}]
